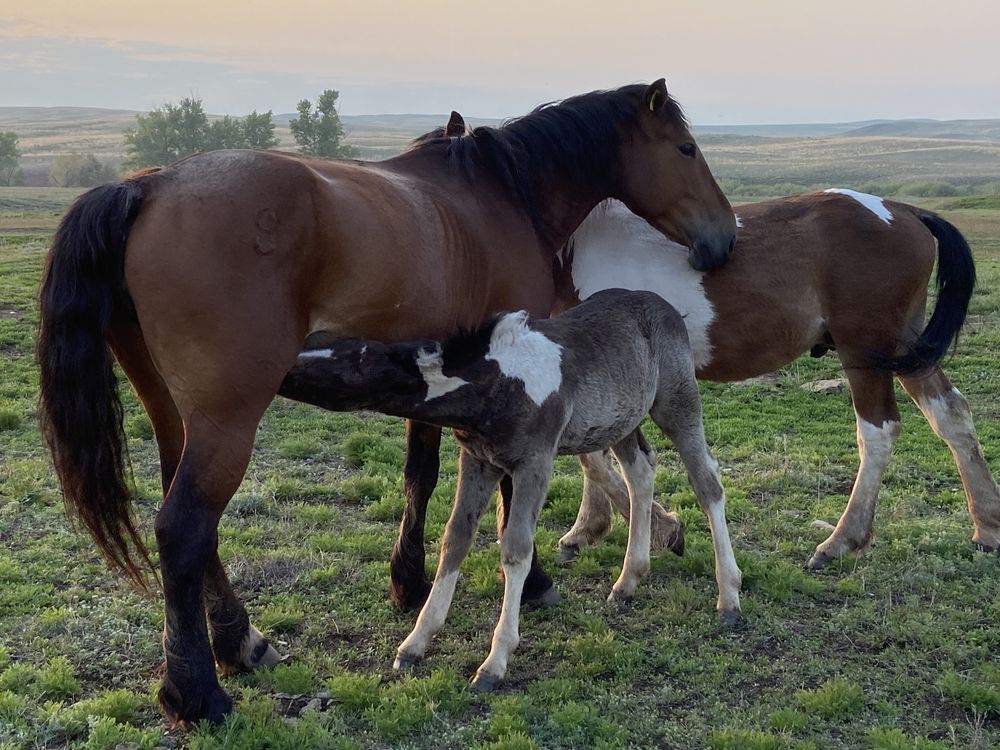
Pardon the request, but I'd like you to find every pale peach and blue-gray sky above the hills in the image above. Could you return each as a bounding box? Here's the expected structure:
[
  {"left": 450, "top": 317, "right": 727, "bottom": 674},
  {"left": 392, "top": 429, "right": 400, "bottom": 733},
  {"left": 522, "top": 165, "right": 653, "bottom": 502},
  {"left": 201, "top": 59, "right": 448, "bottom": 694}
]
[{"left": 0, "top": 0, "right": 1000, "bottom": 125}]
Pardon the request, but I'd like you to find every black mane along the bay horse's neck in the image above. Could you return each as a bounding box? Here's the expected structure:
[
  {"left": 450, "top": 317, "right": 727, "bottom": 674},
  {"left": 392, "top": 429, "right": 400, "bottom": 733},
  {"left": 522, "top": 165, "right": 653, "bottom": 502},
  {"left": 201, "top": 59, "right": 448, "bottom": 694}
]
[{"left": 410, "top": 84, "right": 687, "bottom": 239}]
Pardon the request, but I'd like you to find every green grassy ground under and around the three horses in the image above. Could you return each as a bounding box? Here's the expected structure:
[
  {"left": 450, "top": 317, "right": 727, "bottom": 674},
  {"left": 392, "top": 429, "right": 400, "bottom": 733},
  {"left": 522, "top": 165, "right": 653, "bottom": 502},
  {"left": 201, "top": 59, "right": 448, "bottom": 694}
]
[{"left": 0, "top": 178, "right": 1000, "bottom": 750}]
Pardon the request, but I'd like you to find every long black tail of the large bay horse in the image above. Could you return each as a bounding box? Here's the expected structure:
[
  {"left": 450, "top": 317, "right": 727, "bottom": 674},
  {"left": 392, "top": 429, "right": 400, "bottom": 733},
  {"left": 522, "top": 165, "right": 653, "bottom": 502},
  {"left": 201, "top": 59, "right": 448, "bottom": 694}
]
[{"left": 36, "top": 181, "right": 151, "bottom": 588}]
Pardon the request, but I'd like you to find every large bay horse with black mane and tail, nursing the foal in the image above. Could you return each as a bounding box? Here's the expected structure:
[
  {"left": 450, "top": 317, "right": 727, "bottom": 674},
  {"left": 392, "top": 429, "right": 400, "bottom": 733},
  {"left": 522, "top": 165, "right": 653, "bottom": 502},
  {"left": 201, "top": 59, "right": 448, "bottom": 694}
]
[{"left": 37, "top": 79, "right": 736, "bottom": 724}]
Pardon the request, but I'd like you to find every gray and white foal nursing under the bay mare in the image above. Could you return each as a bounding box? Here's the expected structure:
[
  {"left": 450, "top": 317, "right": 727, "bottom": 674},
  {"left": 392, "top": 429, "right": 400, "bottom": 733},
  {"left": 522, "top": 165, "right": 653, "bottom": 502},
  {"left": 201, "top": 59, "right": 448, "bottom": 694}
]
[{"left": 280, "top": 289, "right": 741, "bottom": 690}]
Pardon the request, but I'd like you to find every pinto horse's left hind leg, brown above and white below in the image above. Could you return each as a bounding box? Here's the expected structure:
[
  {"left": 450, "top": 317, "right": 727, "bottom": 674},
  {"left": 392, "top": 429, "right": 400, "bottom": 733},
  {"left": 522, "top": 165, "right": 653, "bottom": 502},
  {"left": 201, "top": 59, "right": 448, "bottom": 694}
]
[{"left": 809, "top": 367, "right": 899, "bottom": 570}]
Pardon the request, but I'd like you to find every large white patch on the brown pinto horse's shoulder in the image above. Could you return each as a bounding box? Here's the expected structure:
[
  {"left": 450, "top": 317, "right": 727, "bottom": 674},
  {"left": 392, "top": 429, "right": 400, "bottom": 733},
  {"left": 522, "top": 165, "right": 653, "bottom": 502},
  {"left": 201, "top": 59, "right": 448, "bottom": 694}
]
[{"left": 571, "top": 201, "right": 715, "bottom": 367}]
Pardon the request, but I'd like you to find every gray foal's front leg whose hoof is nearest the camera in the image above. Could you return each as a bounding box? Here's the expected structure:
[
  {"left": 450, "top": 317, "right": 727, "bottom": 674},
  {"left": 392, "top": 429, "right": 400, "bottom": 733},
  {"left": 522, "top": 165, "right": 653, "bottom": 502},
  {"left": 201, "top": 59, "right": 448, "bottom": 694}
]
[{"left": 472, "top": 456, "right": 553, "bottom": 692}]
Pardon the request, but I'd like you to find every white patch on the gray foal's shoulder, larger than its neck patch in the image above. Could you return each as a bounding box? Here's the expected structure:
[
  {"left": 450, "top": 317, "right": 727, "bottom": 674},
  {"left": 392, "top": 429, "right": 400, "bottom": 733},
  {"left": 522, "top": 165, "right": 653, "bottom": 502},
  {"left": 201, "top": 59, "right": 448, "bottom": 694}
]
[{"left": 486, "top": 310, "right": 562, "bottom": 406}]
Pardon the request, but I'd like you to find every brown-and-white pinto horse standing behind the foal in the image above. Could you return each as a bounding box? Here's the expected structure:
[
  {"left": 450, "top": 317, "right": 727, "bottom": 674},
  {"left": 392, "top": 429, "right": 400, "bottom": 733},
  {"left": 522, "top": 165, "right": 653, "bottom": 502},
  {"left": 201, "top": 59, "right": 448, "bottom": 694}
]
[{"left": 390, "top": 185, "right": 984, "bottom": 601}]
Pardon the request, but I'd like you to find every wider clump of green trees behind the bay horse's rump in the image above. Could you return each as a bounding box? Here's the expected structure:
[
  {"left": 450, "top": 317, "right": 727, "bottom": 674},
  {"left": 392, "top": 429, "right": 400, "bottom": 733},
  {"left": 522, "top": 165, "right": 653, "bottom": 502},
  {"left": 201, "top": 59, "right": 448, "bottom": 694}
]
[{"left": 125, "top": 98, "right": 278, "bottom": 169}]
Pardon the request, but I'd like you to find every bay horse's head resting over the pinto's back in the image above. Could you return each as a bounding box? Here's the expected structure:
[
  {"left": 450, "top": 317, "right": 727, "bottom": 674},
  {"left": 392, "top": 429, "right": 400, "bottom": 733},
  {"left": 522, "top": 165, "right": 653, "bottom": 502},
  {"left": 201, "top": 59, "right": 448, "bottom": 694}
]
[{"left": 614, "top": 78, "right": 736, "bottom": 271}]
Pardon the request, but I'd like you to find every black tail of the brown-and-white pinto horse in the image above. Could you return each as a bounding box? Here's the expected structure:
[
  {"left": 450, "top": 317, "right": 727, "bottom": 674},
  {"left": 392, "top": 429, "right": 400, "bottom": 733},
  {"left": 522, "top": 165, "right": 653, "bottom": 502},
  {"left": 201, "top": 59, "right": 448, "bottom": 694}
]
[{"left": 887, "top": 209, "right": 976, "bottom": 375}]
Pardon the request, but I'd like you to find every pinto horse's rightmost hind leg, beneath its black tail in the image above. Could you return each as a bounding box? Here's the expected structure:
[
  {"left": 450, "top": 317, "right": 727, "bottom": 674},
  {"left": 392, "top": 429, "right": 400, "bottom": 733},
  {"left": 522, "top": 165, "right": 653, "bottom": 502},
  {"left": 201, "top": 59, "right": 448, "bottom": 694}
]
[{"left": 899, "top": 367, "right": 1000, "bottom": 551}]
